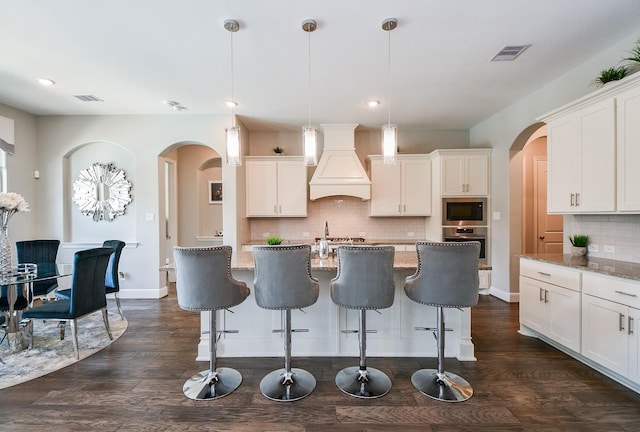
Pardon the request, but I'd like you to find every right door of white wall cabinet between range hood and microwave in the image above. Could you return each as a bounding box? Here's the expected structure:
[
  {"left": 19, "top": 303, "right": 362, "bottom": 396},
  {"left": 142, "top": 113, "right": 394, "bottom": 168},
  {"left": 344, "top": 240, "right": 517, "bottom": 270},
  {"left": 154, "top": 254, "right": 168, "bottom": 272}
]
[{"left": 400, "top": 160, "right": 431, "bottom": 216}]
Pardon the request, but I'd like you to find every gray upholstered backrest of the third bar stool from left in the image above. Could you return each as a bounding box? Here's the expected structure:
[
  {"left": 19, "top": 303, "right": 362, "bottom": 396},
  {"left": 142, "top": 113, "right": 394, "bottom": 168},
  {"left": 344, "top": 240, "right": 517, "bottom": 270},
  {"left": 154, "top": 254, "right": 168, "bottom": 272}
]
[{"left": 331, "top": 246, "right": 395, "bottom": 309}]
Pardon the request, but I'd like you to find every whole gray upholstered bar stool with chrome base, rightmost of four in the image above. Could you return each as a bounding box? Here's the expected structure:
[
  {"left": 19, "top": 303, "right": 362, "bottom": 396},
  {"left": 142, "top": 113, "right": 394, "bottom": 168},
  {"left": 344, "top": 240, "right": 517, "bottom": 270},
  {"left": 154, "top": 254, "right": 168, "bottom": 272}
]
[{"left": 404, "top": 242, "right": 480, "bottom": 402}]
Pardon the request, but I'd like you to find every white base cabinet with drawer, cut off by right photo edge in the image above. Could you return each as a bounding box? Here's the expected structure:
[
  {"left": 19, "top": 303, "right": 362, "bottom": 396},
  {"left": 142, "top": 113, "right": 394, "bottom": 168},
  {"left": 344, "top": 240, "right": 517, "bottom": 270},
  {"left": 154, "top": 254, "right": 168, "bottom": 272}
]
[{"left": 582, "top": 274, "right": 640, "bottom": 383}]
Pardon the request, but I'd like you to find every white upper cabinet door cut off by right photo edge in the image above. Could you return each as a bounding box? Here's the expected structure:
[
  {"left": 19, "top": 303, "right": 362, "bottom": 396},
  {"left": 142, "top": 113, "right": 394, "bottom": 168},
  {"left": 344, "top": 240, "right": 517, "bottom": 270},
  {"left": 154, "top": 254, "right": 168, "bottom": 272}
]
[{"left": 616, "top": 87, "right": 640, "bottom": 212}]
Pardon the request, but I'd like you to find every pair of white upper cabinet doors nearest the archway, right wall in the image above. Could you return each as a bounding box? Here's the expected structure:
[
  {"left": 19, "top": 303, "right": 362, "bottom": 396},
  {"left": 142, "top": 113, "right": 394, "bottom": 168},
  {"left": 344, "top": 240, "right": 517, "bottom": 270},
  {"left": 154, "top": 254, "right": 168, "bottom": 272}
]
[{"left": 547, "top": 97, "right": 616, "bottom": 213}]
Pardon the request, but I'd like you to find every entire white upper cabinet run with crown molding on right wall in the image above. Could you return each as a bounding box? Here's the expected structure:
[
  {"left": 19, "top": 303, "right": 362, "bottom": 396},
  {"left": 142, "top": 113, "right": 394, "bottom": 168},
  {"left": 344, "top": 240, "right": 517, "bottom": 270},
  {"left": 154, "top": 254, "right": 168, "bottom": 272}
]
[{"left": 539, "top": 74, "right": 640, "bottom": 213}]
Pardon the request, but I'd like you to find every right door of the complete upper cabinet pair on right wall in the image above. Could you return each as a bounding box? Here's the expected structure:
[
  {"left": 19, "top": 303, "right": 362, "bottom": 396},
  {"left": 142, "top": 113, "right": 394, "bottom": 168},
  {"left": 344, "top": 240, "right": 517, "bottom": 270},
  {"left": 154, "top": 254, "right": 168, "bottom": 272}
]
[{"left": 574, "top": 99, "right": 616, "bottom": 212}]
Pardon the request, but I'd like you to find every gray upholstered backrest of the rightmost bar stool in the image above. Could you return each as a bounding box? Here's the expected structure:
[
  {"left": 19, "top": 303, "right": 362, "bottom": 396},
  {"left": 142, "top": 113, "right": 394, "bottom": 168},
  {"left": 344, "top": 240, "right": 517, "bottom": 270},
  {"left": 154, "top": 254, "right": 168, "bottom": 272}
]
[{"left": 404, "top": 242, "right": 480, "bottom": 307}]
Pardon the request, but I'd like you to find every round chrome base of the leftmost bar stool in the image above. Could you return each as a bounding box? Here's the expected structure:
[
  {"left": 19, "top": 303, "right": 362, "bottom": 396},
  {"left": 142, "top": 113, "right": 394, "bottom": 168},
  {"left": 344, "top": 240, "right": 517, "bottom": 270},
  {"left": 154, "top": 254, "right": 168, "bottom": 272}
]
[{"left": 182, "top": 368, "right": 242, "bottom": 400}]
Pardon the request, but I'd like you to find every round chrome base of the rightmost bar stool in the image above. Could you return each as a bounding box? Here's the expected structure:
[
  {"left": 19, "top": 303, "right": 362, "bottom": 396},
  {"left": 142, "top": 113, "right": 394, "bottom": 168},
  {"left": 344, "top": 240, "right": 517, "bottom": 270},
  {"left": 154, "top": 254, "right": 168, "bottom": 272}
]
[{"left": 411, "top": 369, "right": 473, "bottom": 402}]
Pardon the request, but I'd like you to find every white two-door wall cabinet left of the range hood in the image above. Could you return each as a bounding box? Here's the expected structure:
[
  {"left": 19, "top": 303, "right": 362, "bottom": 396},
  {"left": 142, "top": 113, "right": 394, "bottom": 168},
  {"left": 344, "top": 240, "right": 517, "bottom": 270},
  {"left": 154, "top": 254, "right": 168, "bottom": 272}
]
[{"left": 246, "top": 156, "right": 307, "bottom": 217}]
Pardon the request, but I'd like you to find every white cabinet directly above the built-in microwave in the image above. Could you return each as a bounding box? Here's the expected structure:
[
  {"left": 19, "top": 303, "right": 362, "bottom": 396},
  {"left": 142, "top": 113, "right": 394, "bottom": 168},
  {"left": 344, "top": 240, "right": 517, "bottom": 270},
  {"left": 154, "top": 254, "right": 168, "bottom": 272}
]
[{"left": 435, "top": 149, "right": 490, "bottom": 197}]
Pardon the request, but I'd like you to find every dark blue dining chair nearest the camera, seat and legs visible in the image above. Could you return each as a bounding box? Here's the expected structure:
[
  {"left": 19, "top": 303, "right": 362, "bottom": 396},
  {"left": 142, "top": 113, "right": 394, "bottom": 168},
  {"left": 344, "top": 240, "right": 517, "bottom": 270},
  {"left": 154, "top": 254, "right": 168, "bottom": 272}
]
[{"left": 22, "top": 248, "right": 113, "bottom": 359}]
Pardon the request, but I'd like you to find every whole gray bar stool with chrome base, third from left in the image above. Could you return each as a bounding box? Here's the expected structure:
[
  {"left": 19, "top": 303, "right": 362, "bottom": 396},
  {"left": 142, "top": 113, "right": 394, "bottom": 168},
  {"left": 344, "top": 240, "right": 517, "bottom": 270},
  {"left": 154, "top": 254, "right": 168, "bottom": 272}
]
[{"left": 331, "top": 246, "right": 395, "bottom": 399}]
